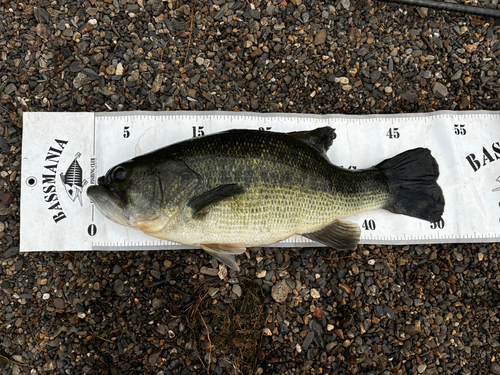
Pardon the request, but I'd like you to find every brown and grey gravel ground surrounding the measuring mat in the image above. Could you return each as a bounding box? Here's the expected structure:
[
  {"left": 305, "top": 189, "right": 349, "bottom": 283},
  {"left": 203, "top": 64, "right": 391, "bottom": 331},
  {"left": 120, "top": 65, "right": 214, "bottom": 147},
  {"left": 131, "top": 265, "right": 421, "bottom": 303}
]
[{"left": 0, "top": 0, "right": 500, "bottom": 375}]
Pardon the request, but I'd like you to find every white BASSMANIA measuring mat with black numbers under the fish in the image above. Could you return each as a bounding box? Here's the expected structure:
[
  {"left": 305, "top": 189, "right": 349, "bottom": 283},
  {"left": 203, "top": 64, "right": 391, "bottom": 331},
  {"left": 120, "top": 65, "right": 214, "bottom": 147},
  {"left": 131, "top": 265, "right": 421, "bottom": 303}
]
[{"left": 20, "top": 111, "right": 500, "bottom": 251}]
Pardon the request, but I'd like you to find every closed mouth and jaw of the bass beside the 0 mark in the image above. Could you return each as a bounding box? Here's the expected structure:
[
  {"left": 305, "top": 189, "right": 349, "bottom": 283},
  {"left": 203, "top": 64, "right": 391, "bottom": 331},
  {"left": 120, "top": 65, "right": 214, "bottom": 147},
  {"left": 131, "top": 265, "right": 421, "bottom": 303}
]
[{"left": 87, "top": 181, "right": 131, "bottom": 227}]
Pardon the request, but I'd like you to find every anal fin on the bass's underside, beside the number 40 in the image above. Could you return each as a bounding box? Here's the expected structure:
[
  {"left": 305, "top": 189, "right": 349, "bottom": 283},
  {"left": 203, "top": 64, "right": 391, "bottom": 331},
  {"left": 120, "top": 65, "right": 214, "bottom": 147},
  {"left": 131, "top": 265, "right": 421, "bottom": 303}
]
[{"left": 302, "top": 220, "right": 361, "bottom": 250}]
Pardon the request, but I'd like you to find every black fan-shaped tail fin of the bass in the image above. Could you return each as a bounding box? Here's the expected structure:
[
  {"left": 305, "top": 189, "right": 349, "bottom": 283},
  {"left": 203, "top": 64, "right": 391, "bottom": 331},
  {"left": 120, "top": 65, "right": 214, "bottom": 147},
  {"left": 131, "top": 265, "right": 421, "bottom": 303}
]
[{"left": 375, "top": 148, "right": 444, "bottom": 222}]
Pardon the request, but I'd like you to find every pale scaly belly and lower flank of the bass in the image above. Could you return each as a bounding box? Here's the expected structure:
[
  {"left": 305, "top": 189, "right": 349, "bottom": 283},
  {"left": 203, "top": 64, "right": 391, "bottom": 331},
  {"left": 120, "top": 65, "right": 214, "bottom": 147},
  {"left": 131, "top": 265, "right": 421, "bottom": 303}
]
[{"left": 155, "top": 187, "right": 386, "bottom": 247}]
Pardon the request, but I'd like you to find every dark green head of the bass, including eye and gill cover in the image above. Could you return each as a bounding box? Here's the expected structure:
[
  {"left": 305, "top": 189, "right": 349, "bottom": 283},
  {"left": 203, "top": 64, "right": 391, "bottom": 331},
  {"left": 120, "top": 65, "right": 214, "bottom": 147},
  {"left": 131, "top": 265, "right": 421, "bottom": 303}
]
[{"left": 87, "top": 159, "right": 170, "bottom": 233}]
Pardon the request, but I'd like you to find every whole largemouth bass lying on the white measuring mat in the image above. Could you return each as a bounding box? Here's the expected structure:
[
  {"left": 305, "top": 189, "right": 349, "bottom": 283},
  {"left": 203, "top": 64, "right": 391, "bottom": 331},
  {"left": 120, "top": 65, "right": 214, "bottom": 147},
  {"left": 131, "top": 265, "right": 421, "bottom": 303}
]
[{"left": 87, "top": 126, "right": 445, "bottom": 271}]
